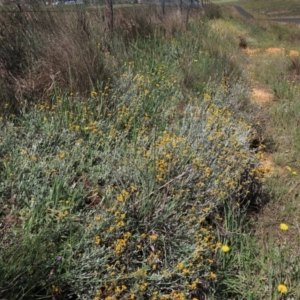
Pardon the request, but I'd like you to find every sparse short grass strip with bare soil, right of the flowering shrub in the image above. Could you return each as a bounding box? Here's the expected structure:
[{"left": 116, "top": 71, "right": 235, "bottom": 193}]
[{"left": 210, "top": 7, "right": 300, "bottom": 299}]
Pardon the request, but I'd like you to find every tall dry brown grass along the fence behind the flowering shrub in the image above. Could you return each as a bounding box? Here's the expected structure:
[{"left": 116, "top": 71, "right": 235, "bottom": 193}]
[{"left": 0, "top": 7, "right": 193, "bottom": 109}]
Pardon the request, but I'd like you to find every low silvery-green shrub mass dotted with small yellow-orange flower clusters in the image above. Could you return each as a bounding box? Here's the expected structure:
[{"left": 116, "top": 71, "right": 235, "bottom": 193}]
[{"left": 1, "top": 66, "right": 257, "bottom": 299}]
